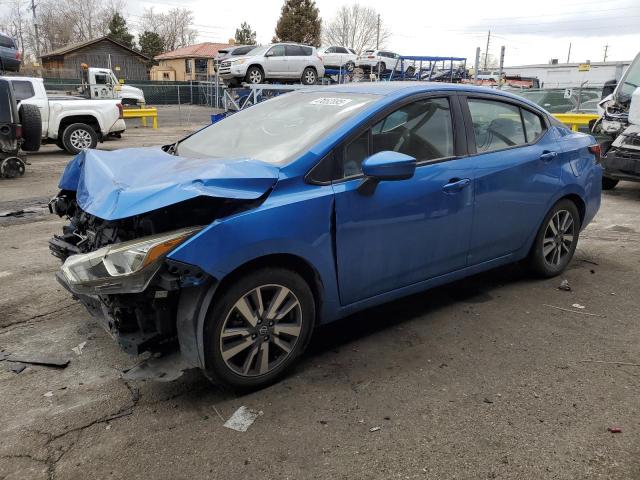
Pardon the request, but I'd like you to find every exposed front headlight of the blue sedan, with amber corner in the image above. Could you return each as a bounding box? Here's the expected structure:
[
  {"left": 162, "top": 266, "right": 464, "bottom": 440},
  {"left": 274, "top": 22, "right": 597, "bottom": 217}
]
[{"left": 62, "top": 227, "right": 201, "bottom": 295}]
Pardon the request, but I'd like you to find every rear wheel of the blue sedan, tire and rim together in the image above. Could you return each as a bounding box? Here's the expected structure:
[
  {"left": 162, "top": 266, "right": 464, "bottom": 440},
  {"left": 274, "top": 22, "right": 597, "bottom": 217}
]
[{"left": 528, "top": 199, "right": 580, "bottom": 278}]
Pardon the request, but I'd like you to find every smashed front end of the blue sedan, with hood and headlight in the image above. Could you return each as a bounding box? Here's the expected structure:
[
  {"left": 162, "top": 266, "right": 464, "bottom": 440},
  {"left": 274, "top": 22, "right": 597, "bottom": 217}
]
[{"left": 49, "top": 149, "right": 277, "bottom": 366}]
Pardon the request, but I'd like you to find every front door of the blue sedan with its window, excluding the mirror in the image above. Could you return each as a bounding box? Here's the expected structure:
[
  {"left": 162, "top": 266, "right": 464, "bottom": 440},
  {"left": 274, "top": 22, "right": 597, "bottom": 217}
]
[{"left": 334, "top": 97, "right": 473, "bottom": 305}]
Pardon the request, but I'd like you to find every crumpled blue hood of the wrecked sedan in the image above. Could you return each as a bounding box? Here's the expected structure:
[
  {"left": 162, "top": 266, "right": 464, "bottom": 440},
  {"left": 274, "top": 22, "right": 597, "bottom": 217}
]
[{"left": 58, "top": 147, "right": 279, "bottom": 220}]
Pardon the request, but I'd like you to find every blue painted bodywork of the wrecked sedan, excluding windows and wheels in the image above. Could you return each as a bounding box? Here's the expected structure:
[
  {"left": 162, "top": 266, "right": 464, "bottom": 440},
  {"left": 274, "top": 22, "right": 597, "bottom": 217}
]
[{"left": 60, "top": 82, "right": 601, "bottom": 336}]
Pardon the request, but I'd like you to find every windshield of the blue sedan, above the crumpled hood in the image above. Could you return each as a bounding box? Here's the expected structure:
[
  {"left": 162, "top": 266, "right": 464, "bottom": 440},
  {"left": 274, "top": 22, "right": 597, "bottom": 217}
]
[{"left": 177, "top": 91, "right": 379, "bottom": 164}]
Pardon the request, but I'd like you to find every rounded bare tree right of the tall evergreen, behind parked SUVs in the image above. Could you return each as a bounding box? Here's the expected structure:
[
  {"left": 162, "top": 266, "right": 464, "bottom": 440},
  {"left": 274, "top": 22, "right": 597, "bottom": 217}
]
[{"left": 322, "top": 3, "right": 391, "bottom": 54}]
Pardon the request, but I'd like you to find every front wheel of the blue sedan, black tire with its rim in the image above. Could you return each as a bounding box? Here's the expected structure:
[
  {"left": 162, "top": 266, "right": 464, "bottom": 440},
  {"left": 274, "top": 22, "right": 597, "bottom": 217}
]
[{"left": 204, "top": 268, "right": 315, "bottom": 390}]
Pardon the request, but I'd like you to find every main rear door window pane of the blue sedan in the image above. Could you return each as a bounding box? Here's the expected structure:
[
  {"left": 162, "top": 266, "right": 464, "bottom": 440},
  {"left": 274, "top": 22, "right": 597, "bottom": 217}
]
[{"left": 467, "top": 98, "right": 527, "bottom": 153}]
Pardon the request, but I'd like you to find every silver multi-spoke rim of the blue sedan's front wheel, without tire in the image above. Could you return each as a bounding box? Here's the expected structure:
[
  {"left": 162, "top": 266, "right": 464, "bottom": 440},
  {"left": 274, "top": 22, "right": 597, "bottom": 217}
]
[{"left": 220, "top": 284, "right": 303, "bottom": 377}]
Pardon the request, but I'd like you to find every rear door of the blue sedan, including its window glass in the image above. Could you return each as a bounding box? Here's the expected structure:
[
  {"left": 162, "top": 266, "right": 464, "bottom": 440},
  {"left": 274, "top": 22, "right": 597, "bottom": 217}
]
[{"left": 463, "top": 96, "right": 561, "bottom": 265}]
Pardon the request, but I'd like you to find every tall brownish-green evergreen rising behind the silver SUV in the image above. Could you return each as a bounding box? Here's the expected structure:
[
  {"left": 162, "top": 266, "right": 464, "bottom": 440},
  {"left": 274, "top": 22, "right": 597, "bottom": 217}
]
[{"left": 273, "top": 0, "right": 322, "bottom": 47}]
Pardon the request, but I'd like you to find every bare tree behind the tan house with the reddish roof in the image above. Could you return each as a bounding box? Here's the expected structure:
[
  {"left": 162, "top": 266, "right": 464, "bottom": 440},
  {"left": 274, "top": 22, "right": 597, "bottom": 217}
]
[{"left": 141, "top": 7, "right": 198, "bottom": 51}]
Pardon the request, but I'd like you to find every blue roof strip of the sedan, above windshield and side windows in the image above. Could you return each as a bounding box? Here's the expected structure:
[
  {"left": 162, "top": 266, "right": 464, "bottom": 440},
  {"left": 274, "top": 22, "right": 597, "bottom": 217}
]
[{"left": 305, "top": 81, "right": 540, "bottom": 110}]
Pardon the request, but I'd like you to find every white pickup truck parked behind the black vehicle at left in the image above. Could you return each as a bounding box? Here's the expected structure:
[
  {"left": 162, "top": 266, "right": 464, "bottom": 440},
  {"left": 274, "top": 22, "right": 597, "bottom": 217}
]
[{"left": 0, "top": 77, "right": 127, "bottom": 154}]
